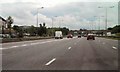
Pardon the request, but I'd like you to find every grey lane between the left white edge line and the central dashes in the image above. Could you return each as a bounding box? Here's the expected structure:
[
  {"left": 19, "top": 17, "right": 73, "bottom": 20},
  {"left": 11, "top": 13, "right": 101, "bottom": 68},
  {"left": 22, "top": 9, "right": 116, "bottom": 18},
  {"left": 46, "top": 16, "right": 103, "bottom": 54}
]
[{"left": 3, "top": 39, "right": 77, "bottom": 70}]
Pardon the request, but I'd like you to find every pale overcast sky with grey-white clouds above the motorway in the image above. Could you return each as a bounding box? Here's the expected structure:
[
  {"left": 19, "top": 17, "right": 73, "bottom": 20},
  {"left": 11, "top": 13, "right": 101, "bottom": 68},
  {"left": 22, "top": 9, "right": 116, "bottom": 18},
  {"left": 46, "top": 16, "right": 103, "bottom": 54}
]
[{"left": 0, "top": 0, "right": 119, "bottom": 29}]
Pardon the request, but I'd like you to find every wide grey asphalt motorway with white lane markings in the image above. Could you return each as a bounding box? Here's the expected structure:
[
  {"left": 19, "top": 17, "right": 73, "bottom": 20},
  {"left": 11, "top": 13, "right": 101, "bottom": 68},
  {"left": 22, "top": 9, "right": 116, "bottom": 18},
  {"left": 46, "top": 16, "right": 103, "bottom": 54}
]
[{"left": 0, "top": 37, "right": 118, "bottom": 70}]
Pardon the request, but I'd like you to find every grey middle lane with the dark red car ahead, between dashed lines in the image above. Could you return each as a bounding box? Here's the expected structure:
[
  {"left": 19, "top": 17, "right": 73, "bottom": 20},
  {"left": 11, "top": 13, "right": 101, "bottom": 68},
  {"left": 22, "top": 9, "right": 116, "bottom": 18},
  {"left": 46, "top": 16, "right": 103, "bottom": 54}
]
[{"left": 45, "top": 38, "right": 118, "bottom": 70}]
